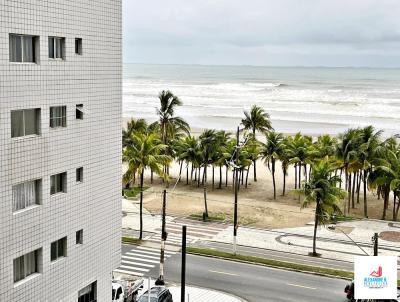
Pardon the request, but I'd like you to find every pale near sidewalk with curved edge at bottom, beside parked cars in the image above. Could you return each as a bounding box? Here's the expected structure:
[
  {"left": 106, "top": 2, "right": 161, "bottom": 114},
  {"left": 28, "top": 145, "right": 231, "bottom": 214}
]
[{"left": 169, "top": 286, "right": 245, "bottom": 302}]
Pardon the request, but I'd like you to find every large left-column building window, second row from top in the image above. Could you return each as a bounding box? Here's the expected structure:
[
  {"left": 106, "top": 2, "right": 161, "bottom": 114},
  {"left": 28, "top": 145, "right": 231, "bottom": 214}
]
[{"left": 11, "top": 108, "right": 40, "bottom": 137}]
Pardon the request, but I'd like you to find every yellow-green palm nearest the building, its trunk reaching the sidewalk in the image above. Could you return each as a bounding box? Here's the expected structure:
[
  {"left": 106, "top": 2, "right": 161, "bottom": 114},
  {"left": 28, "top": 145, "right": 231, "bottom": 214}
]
[{"left": 123, "top": 132, "right": 172, "bottom": 239}]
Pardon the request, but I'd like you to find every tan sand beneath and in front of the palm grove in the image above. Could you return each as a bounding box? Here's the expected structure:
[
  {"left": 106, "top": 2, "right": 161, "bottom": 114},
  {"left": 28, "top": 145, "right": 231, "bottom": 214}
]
[{"left": 124, "top": 153, "right": 393, "bottom": 228}]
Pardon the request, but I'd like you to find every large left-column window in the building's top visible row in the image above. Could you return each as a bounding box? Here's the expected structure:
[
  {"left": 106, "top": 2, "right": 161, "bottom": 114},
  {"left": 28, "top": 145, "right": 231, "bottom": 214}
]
[{"left": 9, "top": 34, "right": 39, "bottom": 63}]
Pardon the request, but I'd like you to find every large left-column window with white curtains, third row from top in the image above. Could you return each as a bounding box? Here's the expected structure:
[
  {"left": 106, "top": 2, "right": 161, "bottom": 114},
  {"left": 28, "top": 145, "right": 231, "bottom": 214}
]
[{"left": 12, "top": 179, "right": 42, "bottom": 212}]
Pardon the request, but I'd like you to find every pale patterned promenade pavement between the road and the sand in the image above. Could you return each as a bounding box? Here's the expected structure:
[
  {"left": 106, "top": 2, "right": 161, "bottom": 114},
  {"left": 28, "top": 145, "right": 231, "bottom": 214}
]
[{"left": 122, "top": 200, "right": 400, "bottom": 262}]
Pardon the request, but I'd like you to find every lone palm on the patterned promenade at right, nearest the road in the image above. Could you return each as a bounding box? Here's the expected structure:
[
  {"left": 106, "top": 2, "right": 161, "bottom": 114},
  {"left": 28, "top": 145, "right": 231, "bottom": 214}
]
[{"left": 296, "top": 158, "right": 346, "bottom": 256}]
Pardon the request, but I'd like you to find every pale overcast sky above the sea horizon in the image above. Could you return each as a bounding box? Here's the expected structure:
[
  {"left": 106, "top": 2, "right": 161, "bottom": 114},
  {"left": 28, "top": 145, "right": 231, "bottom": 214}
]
[{"left": 122, "top": 0, "right": 400, "bottom": 68}]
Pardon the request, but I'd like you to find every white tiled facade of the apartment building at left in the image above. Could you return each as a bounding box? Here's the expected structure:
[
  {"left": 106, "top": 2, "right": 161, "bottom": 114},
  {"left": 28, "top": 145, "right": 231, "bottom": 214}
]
[{"left": 0, "top": 0, "right": 122, "bottom": 302}]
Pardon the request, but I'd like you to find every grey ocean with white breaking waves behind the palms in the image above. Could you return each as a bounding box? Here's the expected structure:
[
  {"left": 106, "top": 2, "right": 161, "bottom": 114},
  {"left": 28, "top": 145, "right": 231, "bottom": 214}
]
[{"left": 123, "top": 64, "right": 400, "bottom": 136}]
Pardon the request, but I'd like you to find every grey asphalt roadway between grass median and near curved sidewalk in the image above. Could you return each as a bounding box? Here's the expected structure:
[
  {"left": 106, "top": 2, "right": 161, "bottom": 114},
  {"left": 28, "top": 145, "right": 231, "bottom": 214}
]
[{"left": 117, "top": 245, "right": 346, "bottom": 302}]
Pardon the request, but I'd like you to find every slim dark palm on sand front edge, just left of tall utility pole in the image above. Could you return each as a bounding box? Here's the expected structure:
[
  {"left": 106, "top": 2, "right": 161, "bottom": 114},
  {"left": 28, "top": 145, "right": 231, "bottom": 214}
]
[{"left": 199, "top": 130, "right": 218, "bottom": 217}]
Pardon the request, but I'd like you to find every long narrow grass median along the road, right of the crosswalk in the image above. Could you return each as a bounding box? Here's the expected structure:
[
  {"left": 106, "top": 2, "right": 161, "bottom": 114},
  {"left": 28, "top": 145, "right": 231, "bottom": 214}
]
[{"left": 187, "top": 247, "right": 354, "bottom": 280}]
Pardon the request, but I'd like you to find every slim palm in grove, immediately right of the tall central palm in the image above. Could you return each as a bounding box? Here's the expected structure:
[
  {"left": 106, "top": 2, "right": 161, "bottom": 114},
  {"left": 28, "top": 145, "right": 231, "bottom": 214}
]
[{"left": 260, "top": 131, "right": 283, "bottom": 199}]
